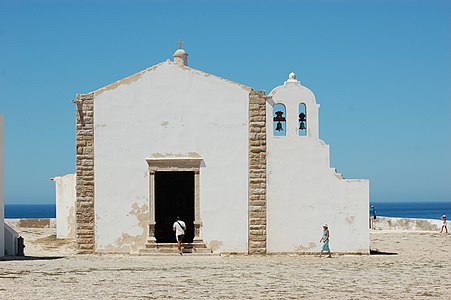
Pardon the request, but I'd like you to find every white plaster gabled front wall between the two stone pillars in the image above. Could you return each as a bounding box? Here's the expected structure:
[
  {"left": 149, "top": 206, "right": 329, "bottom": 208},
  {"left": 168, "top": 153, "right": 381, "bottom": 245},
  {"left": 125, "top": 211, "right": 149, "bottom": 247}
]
[{"left": 94, "top": 61, "right": 250, "bottom": 252}]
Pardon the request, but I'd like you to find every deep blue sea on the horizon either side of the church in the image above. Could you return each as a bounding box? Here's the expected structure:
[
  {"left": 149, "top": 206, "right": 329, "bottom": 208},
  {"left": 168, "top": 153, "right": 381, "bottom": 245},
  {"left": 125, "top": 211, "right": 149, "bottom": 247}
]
[{"left": 5, "top": 201, "right": 451, "bottom": 219}]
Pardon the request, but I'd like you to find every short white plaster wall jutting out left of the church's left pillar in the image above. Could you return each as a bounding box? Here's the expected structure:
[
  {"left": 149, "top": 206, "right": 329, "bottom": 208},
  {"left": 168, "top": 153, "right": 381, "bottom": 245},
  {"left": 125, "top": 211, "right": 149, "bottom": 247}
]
[{"left": 54, "top": 174, "right": 76, "bottom": 239}]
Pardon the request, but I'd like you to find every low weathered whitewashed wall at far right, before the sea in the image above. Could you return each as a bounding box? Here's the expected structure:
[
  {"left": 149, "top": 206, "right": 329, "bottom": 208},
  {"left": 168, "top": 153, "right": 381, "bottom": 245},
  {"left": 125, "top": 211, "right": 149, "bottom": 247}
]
[{"left": 374, "top": 217, "right": 442, "bottom": 231}]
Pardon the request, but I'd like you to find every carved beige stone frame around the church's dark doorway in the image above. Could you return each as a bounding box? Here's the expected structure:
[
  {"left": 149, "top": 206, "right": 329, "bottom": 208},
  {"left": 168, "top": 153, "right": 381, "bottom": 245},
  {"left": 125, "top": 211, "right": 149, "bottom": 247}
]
[{"left": 146, "top": 157, "right": 203, "bottom": 248}]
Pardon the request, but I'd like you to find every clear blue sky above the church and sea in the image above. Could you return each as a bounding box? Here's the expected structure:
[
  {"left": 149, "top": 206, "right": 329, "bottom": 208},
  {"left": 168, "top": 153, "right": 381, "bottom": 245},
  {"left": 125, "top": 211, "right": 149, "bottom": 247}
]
[{"left": 0, "top": 0, "right": 451, "bottom": 204}]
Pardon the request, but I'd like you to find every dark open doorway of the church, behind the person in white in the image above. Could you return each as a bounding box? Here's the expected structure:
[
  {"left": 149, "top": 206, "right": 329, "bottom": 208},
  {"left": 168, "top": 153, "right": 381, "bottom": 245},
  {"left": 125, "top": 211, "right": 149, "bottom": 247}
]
[{"left": 155, "top": 172, "right": 194, "bottom": 243}]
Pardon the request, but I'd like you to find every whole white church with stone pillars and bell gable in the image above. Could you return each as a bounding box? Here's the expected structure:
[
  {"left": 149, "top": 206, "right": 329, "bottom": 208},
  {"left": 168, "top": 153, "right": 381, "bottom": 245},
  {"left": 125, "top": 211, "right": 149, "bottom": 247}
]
[{"left": 55, "top": 48, "right": 369, "bottom": 255}]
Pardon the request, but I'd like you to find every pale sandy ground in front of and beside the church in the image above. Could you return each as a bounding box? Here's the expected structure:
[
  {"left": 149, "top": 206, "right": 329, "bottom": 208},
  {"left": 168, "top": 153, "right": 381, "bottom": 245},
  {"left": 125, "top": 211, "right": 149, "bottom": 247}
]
[{"left": 0, "top": 228, "right": 451, "bottom": 299}]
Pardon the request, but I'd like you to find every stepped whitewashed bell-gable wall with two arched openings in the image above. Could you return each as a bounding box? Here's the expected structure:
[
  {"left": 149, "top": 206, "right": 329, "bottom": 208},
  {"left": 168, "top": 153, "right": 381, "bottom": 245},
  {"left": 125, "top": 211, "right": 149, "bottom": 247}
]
[{"left": 267, "top": 75, "right": 369, "bottom": 253}]
